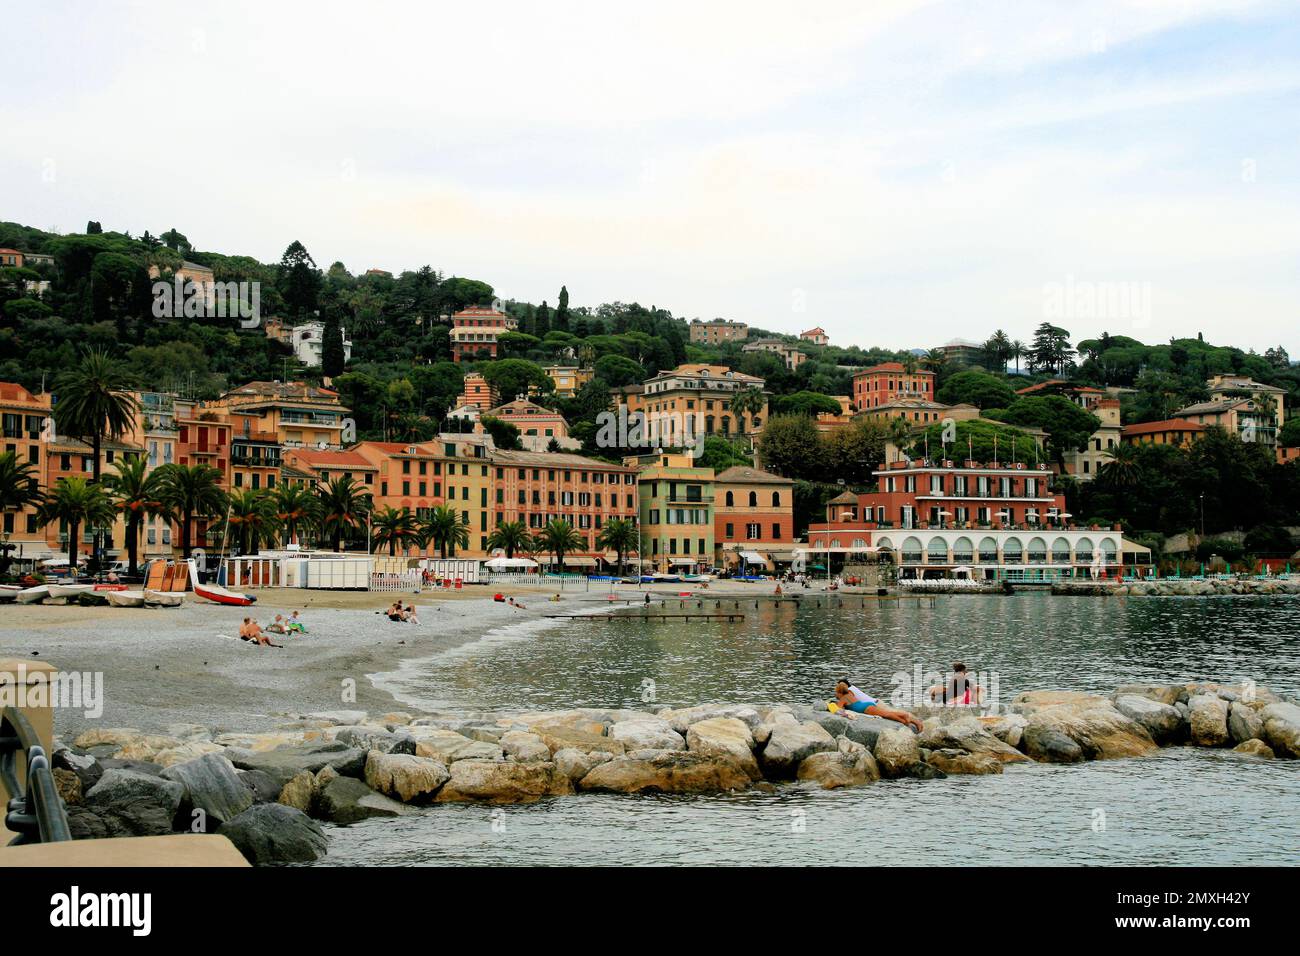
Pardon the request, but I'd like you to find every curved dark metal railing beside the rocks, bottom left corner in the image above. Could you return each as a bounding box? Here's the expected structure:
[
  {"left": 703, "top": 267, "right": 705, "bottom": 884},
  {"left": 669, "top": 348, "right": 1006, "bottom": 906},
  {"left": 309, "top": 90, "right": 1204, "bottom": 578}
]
[{"left": 0, "top": 708, "right": 73, "bottom": 847}]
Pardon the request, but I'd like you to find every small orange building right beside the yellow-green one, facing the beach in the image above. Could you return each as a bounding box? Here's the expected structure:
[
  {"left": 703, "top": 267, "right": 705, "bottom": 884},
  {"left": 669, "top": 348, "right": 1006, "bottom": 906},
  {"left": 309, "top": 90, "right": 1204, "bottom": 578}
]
[{"left": 714, "top": 466, "right": 794, "bottom": 570}]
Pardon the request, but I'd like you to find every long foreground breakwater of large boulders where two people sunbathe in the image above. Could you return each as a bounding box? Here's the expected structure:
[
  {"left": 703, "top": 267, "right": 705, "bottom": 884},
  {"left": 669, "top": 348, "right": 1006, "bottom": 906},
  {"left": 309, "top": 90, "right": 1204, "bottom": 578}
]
[{"left": 52, "top": 684, "right": 1300, "bottom": 864}]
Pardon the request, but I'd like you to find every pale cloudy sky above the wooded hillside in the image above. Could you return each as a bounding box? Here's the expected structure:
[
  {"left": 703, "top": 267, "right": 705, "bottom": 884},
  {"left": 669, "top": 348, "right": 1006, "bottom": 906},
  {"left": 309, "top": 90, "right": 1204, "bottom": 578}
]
[{"left": 0, "top": 0, "right": 1300, "bottom": 356}]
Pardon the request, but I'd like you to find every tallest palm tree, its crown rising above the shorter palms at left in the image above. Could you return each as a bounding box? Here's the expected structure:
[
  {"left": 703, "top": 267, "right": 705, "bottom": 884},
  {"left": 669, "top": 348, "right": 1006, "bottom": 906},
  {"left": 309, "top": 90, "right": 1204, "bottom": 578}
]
[{"left": 53, "top": 349, "right": 139, "bottom": 567}]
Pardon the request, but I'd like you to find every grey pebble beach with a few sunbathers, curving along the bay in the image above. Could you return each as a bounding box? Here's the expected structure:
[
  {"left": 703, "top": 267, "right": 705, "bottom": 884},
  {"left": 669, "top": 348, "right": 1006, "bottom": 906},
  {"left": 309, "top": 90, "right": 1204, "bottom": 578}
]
[{"left": 0, "top": 587, "right": 606, "bottom": 740}]
